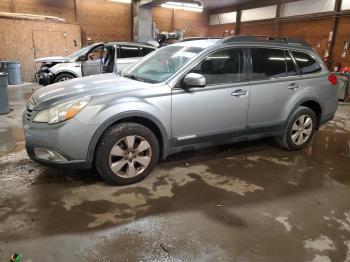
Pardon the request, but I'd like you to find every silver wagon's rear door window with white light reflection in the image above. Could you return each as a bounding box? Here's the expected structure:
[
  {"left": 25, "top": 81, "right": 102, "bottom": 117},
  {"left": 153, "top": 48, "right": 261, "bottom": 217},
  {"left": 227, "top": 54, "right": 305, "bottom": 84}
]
[{"left": 250, "top": 48, "right": 287, "bottom": 80}]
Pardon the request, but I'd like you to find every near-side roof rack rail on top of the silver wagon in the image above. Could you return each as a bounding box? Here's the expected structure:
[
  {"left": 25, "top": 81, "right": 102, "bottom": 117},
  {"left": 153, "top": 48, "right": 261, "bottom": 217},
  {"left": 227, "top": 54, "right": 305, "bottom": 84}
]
[{"left": 221, "top": 35, "right": 310, "bottom": 47}]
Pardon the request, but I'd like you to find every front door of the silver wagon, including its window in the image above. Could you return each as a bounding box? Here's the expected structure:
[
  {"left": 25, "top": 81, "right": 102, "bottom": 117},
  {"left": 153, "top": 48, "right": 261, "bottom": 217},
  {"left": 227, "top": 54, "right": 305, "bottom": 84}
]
[{"left": 172, "top": 48, "right": 250, "bottom": 146}]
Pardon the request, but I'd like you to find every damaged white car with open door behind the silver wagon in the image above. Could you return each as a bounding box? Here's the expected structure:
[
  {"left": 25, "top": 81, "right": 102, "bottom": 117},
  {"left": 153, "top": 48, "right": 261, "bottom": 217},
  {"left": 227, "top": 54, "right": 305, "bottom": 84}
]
[{"left": 35, "top": 42, "right": 157, "bottom": 86}]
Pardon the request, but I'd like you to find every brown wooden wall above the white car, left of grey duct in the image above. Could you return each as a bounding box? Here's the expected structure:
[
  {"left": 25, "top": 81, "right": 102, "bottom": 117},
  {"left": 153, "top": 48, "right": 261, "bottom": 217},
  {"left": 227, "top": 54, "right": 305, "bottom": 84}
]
[{"left": 0, "top": 0, "right": 132, "bottom": 43}]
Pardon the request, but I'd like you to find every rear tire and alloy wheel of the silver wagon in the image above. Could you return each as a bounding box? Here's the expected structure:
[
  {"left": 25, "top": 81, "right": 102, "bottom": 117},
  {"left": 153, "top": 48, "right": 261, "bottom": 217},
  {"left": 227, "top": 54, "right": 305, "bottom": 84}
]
[{"left": 277, "top": 106, "right": 317, "bottom": 150}]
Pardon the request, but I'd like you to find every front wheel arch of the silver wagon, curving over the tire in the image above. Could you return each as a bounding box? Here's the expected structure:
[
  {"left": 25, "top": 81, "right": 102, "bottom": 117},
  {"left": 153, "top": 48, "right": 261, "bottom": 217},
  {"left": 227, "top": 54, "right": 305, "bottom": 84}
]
[{"left": 87, "top": 112, "right": 169, "bottom": 163}]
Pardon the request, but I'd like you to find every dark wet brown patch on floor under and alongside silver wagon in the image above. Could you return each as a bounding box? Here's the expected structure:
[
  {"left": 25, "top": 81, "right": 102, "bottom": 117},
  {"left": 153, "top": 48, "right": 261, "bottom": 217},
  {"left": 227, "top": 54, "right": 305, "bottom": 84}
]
[{"left": 0, "top": 130, "right": 350, "bottom": 239}]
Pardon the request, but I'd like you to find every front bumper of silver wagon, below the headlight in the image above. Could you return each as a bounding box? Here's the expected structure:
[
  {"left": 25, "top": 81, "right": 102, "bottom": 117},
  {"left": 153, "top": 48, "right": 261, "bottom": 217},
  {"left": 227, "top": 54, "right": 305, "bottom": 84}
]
[{"left": 23, "top": 112, "right": 95, "bottom": 169}]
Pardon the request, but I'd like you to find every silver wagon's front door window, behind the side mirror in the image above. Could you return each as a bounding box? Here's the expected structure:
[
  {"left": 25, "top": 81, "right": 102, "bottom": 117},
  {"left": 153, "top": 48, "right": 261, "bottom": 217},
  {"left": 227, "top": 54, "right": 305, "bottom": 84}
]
[{"left": 191, "top": 48, "right": 244, "bottom": 85}]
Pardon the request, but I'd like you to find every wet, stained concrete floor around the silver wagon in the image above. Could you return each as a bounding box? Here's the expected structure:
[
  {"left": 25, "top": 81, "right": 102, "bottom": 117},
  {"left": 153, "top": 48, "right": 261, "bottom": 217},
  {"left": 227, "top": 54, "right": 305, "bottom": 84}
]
[{"left": 0, "top": 84, "right": 350, "bottom": 262}]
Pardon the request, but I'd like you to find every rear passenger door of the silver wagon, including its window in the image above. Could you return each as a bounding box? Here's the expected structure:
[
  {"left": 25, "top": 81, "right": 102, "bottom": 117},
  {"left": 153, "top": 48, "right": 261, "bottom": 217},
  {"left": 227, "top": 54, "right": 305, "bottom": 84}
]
[{"left": 247, "top": 47, "right": 300, "bottom": 134}]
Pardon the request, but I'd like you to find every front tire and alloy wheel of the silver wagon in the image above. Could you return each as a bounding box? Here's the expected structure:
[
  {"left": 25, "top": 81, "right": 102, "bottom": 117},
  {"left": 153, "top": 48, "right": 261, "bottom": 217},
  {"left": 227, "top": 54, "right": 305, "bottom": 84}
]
[{"left": 95, "top": 123, "right": 159, "bottom": 185}]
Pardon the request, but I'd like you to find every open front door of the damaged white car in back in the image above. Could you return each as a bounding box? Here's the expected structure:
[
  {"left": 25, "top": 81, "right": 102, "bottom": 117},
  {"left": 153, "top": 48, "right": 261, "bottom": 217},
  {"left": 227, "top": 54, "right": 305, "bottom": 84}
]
[{"left": 81, "top": 45, "right": 105, "bottom": 76}]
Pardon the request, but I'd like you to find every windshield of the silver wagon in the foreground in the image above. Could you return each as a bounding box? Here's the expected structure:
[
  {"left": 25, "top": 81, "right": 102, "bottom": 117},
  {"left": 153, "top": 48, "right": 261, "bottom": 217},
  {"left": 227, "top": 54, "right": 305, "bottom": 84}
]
[{"left": 123, "top": 46, "right": 203, "bottom": 83}]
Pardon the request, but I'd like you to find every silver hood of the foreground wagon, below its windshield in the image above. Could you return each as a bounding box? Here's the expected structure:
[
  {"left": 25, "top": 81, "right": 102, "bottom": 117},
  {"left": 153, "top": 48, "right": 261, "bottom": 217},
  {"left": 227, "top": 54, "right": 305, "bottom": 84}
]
[{"left": 32, "top": 73, "right": 152, "bottom": 110}]
